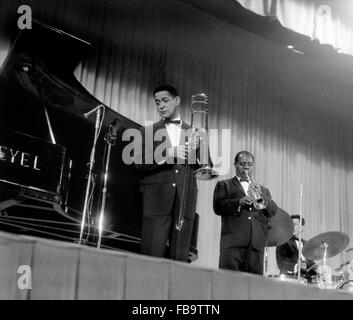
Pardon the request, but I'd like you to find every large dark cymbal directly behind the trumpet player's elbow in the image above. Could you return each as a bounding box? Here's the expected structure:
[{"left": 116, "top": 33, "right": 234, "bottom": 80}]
[{"left": 266, "top": 208, "right": 294, "bottom": 247}]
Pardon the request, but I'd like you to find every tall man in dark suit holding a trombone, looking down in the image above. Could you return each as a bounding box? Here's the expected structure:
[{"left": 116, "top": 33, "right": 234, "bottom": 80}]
[{"left": 135, "top": 85, "right": 200, "bottom": 262}]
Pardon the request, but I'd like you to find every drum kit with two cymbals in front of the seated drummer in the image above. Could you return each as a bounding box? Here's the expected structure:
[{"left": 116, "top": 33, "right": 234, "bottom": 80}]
[{"left": 264, "top": 208, "right": 353, "bottom": 291}]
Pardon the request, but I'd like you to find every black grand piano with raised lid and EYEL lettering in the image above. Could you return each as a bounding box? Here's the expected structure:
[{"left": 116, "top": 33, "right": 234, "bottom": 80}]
[{"left": 0, "top": 20, "right": 198, "bottom": 261}]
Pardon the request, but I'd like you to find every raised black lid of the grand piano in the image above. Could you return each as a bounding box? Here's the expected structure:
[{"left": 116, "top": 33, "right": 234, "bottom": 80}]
[{"left": 0, "top": 20, "right": 140, "bottom": 128}]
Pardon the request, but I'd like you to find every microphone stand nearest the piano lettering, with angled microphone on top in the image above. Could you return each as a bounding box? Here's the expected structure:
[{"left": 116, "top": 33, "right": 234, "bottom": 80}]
[{"left": 78, "top": 105, "right": 103, "bottom": 244}]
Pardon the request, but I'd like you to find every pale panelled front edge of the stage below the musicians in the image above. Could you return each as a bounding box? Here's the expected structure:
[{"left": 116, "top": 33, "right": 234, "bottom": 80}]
[{"left": 0, "top": 232, "right": 353, "bottom": 300}]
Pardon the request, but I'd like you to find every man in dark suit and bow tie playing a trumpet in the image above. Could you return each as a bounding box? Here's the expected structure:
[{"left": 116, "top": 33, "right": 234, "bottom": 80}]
[{"left": 213, "top": 151, "right": 277, "bottom": 274}]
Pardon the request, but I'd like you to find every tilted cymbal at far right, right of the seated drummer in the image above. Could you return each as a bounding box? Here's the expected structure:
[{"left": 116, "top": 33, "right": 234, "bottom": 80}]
[{"left": 303, "top": 231, "right": 349, "bottom": 260}]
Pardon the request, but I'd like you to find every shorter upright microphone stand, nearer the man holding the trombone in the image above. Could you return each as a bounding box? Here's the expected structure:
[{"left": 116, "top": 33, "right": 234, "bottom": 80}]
[{"left": 97, "top": 120, "right": 117, "bottom": 249}]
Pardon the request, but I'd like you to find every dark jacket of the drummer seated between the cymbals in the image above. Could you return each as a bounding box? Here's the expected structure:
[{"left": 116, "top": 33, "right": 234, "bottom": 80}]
[{"left": 276, "top": 236, "right": 315, "bottom": 274}]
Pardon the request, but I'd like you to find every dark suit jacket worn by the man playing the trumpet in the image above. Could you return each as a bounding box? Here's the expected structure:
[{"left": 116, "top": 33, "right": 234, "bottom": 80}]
[{"left": 213, "top": 177, "right": 277, "bottom": 252}]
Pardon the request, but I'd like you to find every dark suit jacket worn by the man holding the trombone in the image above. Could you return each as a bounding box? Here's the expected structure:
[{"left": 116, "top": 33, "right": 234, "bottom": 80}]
[{"left": 135, "top": 120, "right": 199, "bottom": 219}]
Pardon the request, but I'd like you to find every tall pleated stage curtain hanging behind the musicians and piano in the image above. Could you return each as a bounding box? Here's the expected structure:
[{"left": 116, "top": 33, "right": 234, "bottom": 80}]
[{"left": 0, "top": 0, "right": 353, "bottom": 273}]
